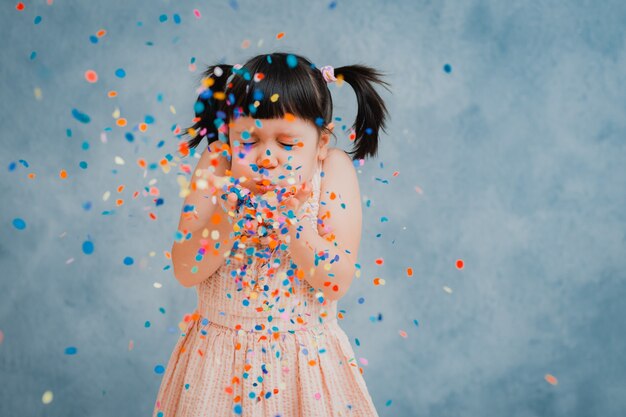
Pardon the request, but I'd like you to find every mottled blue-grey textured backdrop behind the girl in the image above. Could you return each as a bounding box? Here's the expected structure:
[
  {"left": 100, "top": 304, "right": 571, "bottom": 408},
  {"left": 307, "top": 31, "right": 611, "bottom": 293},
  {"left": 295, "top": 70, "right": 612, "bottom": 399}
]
[{"left": 0, "top": 0, "right": 626, "bottom": 417}]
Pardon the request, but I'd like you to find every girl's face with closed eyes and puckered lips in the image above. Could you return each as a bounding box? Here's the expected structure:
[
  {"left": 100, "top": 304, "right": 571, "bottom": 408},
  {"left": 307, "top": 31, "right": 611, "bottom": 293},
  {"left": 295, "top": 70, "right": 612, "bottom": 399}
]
[{"left": 228, "top": 117, "right": 332, "bottom": 194}]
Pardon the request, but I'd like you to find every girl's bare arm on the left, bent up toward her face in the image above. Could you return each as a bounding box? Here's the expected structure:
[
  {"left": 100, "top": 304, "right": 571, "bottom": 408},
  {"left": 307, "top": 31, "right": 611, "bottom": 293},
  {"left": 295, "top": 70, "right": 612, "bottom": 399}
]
[{"left": 172, "top": 144, "right": 234, "bottom": 287}]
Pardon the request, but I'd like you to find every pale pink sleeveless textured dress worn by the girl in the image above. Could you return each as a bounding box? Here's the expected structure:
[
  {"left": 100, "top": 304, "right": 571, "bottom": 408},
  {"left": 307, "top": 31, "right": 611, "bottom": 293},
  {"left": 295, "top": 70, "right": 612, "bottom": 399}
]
[{"left": 153, "top": 160, "right": 378, "bottom": 417}]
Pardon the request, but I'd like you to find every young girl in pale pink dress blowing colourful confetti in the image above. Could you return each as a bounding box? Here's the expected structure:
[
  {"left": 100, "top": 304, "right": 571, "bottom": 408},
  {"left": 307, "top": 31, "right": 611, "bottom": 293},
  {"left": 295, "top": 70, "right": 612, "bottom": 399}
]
[{"left": 153, "top": 53, "right": 389, "bottom": 417}]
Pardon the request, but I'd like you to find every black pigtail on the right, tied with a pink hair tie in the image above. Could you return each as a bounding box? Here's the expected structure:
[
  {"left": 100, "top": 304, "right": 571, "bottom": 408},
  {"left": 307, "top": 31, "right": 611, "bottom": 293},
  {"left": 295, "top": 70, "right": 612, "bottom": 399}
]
[{"left": 334, "top": 64, "right": 391, "bottom": 161}]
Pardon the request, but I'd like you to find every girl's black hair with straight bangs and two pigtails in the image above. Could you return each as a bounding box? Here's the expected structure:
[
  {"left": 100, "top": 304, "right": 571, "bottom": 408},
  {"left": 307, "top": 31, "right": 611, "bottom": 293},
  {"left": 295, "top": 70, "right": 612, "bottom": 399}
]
[{"left": 183, "top": 52, "right": 390, "bottom": 160}]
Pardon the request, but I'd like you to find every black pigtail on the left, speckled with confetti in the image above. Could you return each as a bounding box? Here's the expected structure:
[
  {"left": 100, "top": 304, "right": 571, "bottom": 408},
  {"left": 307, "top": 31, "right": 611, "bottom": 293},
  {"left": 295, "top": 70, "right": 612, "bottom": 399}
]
[{"left": 185, "top": 64, "right": 233, "bottom": 148}]
